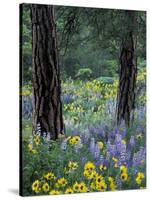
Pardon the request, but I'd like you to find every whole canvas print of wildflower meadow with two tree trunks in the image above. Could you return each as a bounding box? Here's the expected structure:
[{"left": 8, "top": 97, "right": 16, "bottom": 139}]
[{"left": 20, "top": 4, "right": 146, "bottom": 196}]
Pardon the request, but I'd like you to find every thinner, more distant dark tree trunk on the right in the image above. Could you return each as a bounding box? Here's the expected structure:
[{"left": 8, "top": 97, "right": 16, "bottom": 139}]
[{"left": 117, "top": 11, "right": 137, "bottom": 126}]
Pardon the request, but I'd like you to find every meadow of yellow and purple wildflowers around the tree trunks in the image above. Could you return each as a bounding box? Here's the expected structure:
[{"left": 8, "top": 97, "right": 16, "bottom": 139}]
[{"left": 22, "top": 69, "right": 146, "bottom": 195}]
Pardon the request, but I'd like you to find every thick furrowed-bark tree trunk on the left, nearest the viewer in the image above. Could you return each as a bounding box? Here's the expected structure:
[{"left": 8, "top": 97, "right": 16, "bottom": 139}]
[{"left": 31, "top": 5, "right": 63, "bottom": 140}]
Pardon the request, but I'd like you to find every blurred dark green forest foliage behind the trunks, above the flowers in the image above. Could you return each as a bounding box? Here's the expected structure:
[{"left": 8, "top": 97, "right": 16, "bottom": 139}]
[{"left": 21, "top": 4, "right": 146, "bottom": 83}]
